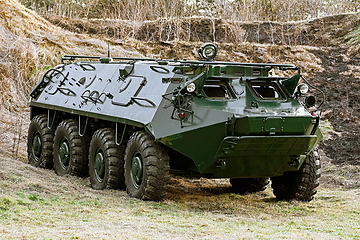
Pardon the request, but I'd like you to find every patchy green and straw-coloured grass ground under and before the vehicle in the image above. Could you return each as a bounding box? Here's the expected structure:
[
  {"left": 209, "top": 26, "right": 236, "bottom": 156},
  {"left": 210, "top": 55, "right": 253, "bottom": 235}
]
[{"left": 0, "top": 157, "right": 360, "bottom": 239}]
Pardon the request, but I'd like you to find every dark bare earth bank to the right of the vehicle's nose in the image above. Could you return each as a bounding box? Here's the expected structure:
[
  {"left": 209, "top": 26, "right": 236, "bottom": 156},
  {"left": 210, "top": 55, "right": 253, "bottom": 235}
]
[{"left": 314, "top": 47, "right": 360, "bottom": 165}]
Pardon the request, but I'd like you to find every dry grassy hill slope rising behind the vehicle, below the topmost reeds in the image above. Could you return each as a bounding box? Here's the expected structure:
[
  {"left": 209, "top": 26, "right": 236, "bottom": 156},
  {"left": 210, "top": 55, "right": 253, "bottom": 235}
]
[{"left": 0, "top": 0, "right": 360, "bottom": 193}]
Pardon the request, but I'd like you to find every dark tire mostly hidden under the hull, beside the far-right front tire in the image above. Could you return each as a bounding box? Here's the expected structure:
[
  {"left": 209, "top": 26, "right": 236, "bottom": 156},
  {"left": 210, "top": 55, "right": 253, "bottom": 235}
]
[{"left": 230, "top": 178, "right": 269, "bottom": 194}]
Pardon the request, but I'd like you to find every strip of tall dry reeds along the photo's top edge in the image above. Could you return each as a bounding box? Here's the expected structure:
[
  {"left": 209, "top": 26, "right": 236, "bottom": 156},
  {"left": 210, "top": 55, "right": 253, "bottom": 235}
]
[{"left": 20, "top": 0, "right": 360, "bottom": 22}]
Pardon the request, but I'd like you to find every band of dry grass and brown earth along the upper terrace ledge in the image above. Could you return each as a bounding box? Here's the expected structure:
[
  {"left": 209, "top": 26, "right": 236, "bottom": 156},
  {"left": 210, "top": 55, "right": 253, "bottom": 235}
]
[{"left": 45, "top": 14, "right": 360, "bottom": 47}]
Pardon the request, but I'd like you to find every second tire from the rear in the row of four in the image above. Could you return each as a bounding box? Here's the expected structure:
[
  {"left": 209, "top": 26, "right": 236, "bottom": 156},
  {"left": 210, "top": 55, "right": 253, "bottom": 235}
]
[{"left": 54, "top": 119, "right": 89, "bottom": 176}]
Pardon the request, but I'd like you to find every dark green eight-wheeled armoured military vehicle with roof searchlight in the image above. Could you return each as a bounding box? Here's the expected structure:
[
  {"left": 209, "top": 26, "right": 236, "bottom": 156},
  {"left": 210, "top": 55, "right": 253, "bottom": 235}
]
[{"left": 28, "top": 43, "right": 324, "bottom": 201}]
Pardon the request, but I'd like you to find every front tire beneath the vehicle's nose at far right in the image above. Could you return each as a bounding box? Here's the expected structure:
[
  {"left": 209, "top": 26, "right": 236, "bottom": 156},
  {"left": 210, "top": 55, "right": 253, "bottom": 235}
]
[{"left": 271, "top": 149, "right": 321, "bottom": 201}]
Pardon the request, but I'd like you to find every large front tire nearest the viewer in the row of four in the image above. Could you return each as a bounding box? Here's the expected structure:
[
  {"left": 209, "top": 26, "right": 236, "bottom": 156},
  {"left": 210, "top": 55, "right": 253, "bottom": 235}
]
[{"left": 125, "top": 131, "right": 170, "bottom": 201}]
